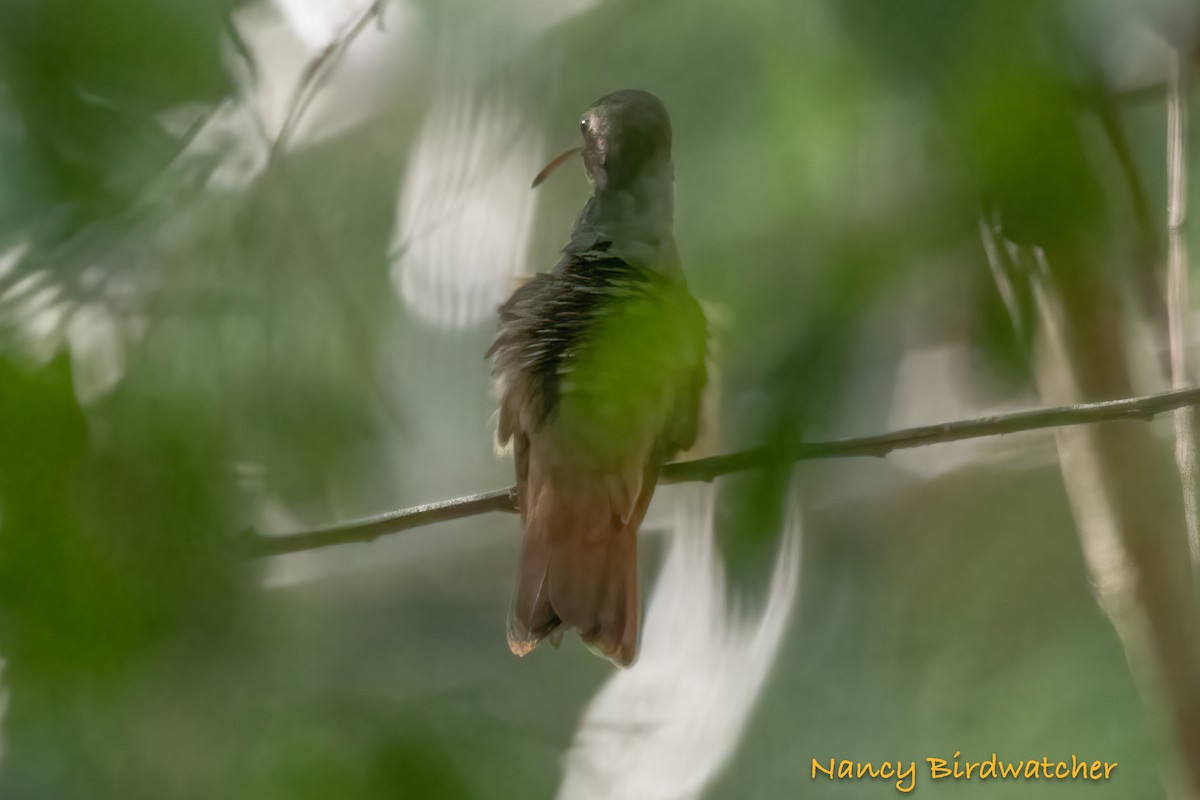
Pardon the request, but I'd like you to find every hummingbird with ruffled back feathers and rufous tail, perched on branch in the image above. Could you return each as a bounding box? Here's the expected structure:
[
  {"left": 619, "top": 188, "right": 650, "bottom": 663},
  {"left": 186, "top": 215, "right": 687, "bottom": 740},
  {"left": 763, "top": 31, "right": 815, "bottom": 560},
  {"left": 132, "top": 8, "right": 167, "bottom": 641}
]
[{"left": 487, "top": 90, "right": 708, "bottom": 667}]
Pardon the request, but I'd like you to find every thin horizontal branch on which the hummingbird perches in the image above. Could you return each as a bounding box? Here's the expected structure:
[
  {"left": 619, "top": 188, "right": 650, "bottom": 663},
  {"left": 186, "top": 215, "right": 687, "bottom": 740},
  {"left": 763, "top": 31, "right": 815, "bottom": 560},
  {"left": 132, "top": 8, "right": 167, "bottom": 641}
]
[{"left": 245, "top": 387, "right": 1200, "bottom": 558}]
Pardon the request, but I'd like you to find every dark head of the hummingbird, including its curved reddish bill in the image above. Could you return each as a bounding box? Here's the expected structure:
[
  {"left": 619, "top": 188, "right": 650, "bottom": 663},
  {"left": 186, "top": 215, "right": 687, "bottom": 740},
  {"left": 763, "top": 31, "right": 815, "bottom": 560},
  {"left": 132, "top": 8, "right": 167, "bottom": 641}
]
[{"left": 533, "top": 89, "right": 671, "bottom": 193}]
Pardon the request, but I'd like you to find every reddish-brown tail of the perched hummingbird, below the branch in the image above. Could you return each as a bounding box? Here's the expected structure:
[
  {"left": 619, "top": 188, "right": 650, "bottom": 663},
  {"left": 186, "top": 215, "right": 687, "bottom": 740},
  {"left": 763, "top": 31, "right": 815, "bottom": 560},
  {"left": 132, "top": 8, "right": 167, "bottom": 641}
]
[{"left": 509, "top": 456, "right": 658, "bottom": 666}]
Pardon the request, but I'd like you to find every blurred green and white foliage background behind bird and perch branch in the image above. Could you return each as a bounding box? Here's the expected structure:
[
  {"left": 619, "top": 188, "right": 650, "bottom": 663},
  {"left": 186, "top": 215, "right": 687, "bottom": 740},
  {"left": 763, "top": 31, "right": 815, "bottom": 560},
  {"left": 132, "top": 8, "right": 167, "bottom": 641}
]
[{"left": 0, "top": 0, "right": 1200, "bottom": 800}]
